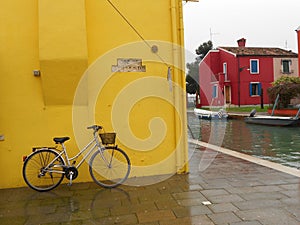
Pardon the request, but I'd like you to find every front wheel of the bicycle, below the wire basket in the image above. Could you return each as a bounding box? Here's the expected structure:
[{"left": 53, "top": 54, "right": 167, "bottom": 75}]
[{"left": 89, "top": 147, "right": 131, "bottom": 188}]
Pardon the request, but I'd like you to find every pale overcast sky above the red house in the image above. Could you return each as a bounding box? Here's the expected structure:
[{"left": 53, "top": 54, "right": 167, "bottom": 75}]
[{"left": 183, "top": 0, "right": 300, "bottom": 61}]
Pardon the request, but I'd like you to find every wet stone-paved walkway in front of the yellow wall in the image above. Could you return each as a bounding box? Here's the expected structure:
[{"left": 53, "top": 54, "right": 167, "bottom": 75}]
[{"left": 0, "top": 144, "right": 300, "bottom": 225}]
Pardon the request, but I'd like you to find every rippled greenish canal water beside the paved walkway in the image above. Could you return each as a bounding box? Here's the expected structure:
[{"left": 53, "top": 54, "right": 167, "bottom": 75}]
[{"left": 188, "top": 112, "right": 300, "bottom": 168}]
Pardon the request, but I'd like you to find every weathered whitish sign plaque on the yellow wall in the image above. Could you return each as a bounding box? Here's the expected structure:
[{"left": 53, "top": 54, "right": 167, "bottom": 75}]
[{"left": 111, "top": 58, "right": 146, "bottom": 72}]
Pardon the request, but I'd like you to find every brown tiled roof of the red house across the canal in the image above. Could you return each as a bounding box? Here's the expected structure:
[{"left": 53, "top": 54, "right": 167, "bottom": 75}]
[{"left": 218, "top": 47, "right": 298, "bottom": 58}]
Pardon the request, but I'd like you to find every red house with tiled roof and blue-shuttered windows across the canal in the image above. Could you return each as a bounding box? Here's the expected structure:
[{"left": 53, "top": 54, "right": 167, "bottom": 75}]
[{"left": 199, "top": 38, "right": 299, "bottom": 106}]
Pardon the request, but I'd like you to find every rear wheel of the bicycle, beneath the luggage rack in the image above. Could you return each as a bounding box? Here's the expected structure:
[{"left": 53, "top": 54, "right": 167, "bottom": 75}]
[{"left": 23, "top": 149, "right": 65, "bottom": 192}]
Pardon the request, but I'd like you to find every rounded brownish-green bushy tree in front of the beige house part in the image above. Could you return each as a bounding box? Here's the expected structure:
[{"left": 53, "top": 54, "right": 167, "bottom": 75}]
[{"left": 268, "top": 76, "right": 300, "bottom": 108}]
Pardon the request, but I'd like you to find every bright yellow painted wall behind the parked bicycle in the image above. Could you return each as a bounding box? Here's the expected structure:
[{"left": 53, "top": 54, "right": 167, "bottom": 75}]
[{"left": 0, "top": 0, "right": 187, "bottom": 188}]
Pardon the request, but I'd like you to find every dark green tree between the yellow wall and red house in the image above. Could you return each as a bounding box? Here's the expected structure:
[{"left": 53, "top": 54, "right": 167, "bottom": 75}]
[{"left": 186, "top": 41, "right": 213, "bottom": 106}]
